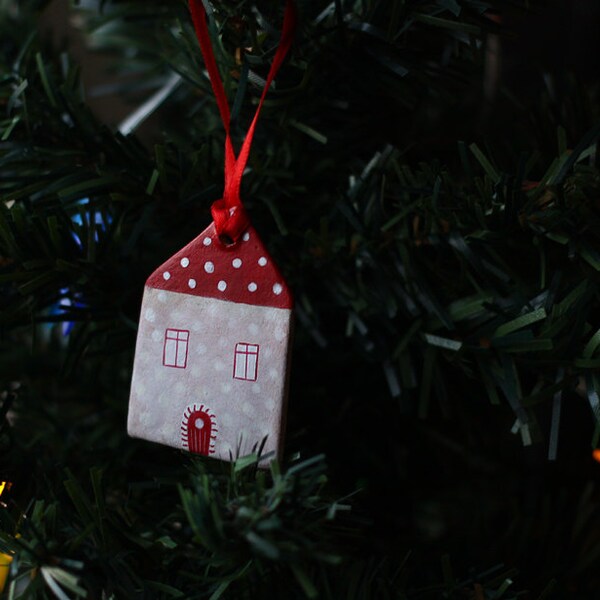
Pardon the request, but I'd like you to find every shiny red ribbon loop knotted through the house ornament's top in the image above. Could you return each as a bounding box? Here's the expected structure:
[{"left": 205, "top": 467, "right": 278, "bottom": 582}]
[{"left": 190, "top": 0, "right": 296, "bottom": 242}]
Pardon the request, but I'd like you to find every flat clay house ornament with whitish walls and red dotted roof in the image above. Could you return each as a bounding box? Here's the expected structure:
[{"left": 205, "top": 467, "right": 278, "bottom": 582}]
[{"left": 128, "top": 225, "right": 293, "bottom": 460}]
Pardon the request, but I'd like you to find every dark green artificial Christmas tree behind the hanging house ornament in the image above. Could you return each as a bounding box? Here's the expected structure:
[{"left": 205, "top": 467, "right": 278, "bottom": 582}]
[{"left": 0, "top": 0, "right": 600, "bottom": 600}]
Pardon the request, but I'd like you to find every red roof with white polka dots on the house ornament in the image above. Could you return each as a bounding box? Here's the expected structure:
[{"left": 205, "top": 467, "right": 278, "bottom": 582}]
[{"left": 146, "top": 223, "right": 294, "bottom": 308}]
